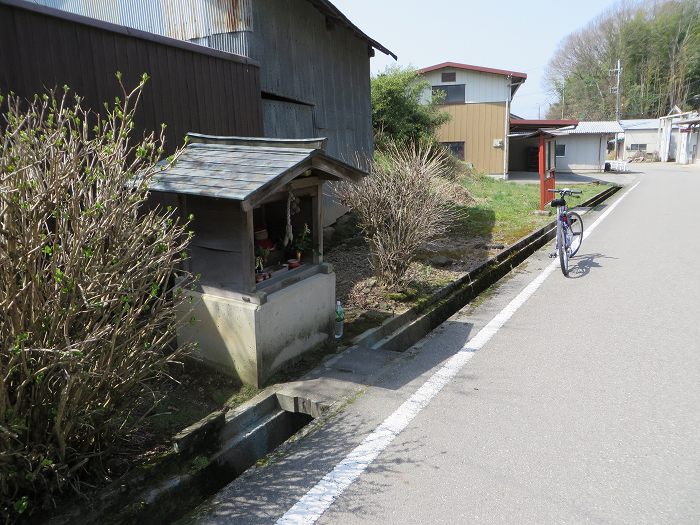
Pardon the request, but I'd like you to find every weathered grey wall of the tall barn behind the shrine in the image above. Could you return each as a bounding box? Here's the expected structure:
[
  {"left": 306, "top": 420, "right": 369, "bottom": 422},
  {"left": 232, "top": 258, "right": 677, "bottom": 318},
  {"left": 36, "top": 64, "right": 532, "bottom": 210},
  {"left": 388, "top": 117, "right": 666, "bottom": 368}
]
[{"left": 248, "top": 0, "right": 373, "bottom": 165}]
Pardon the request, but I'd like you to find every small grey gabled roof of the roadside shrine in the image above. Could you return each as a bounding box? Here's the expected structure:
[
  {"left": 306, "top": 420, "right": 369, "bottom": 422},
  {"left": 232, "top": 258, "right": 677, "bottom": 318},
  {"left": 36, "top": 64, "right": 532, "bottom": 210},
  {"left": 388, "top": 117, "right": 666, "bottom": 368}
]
[{"left": 149, "top": 135, "right": 365, "bottom": 207}]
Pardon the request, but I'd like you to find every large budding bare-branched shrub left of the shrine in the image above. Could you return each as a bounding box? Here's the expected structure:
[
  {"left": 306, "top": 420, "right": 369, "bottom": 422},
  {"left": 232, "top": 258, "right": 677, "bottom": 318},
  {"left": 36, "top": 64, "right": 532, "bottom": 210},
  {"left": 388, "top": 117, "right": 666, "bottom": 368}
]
[{"left": 0, "top": 75, "right": 187, "bottom": 521}]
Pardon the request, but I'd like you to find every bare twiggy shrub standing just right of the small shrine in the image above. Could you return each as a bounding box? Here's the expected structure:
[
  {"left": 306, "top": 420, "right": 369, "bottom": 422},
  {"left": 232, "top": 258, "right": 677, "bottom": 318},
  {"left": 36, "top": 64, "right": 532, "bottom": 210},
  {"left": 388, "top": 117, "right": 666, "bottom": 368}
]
[{"left": 337, "top": 144, "right": 455, "bottom": 287}]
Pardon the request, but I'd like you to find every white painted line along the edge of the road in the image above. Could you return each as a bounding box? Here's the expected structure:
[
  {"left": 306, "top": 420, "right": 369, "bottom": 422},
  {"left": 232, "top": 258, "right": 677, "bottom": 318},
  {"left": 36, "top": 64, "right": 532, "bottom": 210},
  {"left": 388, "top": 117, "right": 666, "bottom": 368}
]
[{"left": 277, "top": 182, "right": 639, "bottom": 525}]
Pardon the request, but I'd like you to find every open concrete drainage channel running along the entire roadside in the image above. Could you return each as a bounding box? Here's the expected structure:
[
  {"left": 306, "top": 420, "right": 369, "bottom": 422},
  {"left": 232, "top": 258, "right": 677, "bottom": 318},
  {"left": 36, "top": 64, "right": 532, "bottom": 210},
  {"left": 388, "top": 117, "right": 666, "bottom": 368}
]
[{"left": 48, "top": 182, "right": 620, "bottom": 525}]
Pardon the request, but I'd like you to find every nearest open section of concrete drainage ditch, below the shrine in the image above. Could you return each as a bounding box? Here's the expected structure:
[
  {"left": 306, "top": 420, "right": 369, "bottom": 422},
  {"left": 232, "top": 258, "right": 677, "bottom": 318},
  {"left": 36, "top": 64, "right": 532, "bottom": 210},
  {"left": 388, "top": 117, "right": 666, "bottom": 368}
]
[{"left": 48, "top": 389, "right": 328, "bottom": 525}]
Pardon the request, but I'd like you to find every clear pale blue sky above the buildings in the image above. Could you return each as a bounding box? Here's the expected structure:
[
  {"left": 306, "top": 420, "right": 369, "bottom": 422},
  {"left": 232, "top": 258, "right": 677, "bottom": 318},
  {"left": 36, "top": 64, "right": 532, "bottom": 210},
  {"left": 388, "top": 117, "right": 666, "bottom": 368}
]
[{"left": 331, "top": 0, "right": 617, "bottom": 118}]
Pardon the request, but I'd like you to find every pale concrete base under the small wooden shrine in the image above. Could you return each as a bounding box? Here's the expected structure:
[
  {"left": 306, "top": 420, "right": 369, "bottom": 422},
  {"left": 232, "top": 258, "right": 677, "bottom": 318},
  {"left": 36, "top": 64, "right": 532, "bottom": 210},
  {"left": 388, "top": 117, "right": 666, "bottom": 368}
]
[{"left": 178, "top": 265, "right": 335, "bottom": 387}]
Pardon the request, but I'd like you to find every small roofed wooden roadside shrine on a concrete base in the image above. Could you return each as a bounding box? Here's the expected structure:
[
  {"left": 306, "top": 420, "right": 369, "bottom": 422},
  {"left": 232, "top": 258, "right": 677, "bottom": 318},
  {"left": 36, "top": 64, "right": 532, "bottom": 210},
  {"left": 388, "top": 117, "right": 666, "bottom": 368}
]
[{"left": 150, "top": 134, "right": 365, "bottom": 386}]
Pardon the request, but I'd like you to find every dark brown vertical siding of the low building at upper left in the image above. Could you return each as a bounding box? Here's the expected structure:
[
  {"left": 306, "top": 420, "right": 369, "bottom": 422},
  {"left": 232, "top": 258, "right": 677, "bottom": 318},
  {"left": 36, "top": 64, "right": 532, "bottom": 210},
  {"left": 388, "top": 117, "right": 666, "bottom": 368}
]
[{"left": 0, "top": 0, "right": 263, "bottom": 150}]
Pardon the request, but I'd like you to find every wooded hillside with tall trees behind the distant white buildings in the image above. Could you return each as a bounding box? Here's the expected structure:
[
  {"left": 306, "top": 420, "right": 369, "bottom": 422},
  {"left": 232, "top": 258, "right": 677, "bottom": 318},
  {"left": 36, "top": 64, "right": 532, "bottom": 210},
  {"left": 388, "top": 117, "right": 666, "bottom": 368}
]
[{"left": 545, "top": 0, "right": 700, "bottom": 120}]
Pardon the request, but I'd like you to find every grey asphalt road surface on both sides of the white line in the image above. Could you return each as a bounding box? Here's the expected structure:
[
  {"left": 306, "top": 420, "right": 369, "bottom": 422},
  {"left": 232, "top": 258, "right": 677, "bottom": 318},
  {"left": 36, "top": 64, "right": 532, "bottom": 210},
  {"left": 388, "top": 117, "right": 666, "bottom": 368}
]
[{"left": 187, "top": 165, "right": 700, "bottom": 525}]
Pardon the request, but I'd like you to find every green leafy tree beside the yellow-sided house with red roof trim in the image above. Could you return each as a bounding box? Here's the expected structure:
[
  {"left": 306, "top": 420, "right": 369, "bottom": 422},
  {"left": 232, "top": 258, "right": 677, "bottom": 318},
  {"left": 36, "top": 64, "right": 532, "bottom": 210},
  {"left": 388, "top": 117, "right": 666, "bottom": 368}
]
[{"left": 372, "top": 66, "right": 450, "bottom": 149}]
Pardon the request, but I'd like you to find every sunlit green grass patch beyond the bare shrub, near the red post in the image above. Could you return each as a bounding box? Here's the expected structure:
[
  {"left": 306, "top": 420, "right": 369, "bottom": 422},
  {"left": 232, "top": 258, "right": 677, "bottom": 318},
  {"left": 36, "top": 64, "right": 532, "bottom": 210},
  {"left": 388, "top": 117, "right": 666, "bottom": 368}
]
[{"left": 459, "top": 175, "right": 605, "bottom": 245}]
